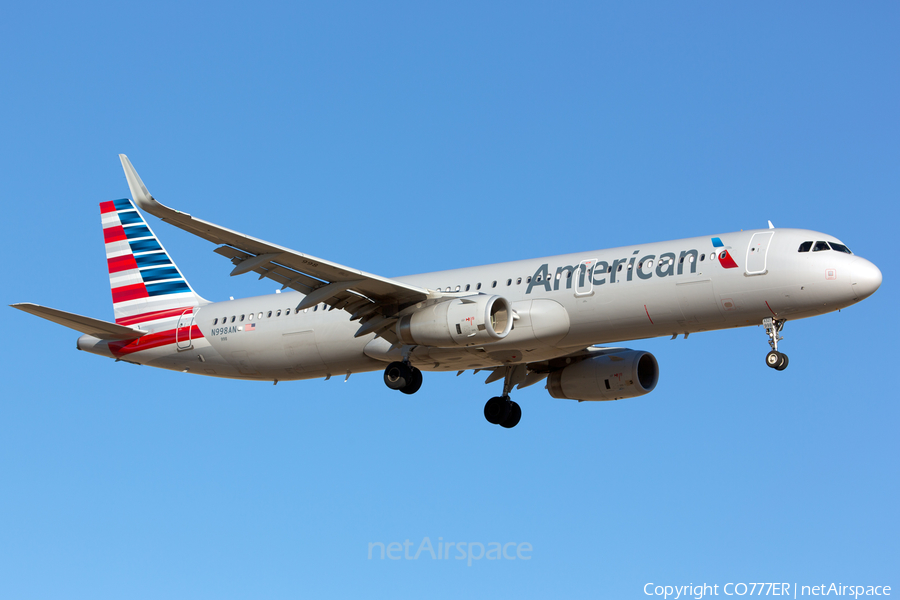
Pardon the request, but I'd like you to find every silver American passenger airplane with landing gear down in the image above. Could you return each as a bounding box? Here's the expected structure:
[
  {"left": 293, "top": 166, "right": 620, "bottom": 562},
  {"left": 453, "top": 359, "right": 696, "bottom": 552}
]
[{"left": 11, "top": 154, "right": 882, "bottom": 429}]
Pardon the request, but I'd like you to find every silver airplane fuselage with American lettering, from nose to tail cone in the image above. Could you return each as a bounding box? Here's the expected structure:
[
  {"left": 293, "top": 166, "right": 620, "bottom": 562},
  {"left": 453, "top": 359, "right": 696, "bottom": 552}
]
[{"left": 78, "top": 229, "right": 881, "bottom": 381}]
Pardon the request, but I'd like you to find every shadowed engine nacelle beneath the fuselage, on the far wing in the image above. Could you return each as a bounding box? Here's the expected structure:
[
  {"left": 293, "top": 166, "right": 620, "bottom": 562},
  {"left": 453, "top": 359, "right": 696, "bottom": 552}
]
[{"left": 547, "top": 350, "right": 659, "bottom": 400}]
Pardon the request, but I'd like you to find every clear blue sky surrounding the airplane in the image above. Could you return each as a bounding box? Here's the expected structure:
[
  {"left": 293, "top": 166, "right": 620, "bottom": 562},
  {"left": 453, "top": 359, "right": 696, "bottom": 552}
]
[{"left": 0, "top": 2, "right": 900, "bottom": 600}]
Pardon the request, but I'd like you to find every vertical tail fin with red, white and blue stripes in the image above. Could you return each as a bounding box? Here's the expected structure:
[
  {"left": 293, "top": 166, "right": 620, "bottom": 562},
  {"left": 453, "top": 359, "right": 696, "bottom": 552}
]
[{"left": 100, "top": 198, "right": 207, "bottom": 326}]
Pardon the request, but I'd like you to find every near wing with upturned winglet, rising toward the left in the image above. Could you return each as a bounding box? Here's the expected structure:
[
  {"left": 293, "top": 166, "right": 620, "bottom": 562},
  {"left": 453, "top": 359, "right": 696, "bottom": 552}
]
[{"left": 119, "top": 154, "right": 434, "bottom": 343}]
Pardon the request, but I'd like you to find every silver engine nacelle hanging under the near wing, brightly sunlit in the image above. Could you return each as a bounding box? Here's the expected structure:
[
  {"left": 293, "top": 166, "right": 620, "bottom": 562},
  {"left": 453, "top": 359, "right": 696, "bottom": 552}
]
[{"left": 397, "top": 294, "right": 513, "bottom": 348}]
